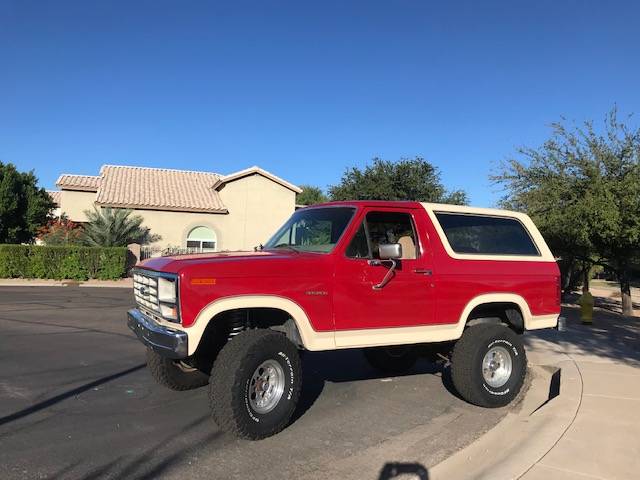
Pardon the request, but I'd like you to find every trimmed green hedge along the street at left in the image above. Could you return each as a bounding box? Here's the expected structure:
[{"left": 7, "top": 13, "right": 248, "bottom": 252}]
[{"left": 0, "top": 245, "right": 127, "bottom": 280}]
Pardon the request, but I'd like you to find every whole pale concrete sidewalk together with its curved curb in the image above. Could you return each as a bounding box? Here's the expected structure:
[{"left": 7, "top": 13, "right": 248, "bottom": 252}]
[{"left": 429, "top": 306, "right": 640, "bottom": 480}]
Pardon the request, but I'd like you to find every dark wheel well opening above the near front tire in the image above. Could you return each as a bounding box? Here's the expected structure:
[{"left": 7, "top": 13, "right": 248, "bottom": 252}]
[{"left": 195, "top": 308, "right": 303, "bottom": 363}]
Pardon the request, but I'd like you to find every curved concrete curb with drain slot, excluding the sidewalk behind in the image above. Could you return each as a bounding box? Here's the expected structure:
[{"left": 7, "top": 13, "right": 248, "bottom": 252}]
[{"left": 429, "top": 354, "right": 582, "bottom": 480}]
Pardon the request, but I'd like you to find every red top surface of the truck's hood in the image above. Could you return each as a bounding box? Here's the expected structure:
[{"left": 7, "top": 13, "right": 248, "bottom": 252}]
[{"left": 138, "top": 249, "right": 316, "bottom": 274}]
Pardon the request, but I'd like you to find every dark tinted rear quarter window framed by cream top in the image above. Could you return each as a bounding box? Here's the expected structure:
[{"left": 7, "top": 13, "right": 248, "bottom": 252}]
[{"left": 435, "top": 212, "right": 540, "bottom": 256}]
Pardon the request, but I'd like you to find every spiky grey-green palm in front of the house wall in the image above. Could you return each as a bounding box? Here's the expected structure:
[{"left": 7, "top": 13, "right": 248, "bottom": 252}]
[{"left": 82, "top": 207, "right": 160, "bottom": 247}]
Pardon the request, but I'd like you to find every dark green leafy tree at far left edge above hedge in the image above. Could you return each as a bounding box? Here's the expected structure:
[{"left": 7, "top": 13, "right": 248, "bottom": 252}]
[{"left": 0, "top": 162, "right": 55, "bottom": 243}]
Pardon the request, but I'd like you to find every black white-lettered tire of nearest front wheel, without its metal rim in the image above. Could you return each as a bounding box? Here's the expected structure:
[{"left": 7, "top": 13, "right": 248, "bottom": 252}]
[{"left": 209, "top": 330, "right": 302, "bottom": 440}]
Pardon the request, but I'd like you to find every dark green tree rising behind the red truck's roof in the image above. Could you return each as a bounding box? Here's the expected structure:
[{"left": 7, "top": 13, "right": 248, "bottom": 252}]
[{"left": 329, "top": 157, "right": 467, "bottom": 205}]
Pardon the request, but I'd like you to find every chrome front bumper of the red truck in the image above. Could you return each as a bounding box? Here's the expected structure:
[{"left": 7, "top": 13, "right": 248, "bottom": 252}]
[{"left": 127, "top": 308, "right": 189, "bottom": 358}]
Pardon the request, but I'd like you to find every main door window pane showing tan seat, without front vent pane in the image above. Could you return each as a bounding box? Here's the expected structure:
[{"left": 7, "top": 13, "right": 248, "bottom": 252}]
[{"left": 366, "top": 212, "right": 418, "bottom": 260}]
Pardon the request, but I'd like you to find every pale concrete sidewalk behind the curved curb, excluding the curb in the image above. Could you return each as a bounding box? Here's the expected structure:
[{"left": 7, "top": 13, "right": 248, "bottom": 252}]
[{"left": 522, "top": 309, "right": 640, "bottom": 480}]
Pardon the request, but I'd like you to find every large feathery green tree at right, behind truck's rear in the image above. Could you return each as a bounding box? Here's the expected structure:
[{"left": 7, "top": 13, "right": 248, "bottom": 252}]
[{"left": 493, "top": 108, "right": 640, "bottom": 315}]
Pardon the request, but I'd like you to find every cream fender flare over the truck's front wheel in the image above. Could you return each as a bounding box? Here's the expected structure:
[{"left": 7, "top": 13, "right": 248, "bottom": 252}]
[{"left": 183, "top": 295, "right": 336, "bottom": 355}]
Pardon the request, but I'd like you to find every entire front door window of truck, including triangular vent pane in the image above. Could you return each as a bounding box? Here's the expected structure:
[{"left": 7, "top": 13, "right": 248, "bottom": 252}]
[{"left": 346, "top": 212, "right": 418, "bottom": 260}]
